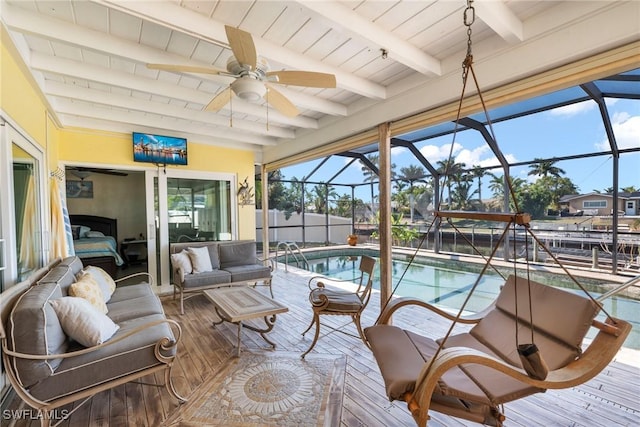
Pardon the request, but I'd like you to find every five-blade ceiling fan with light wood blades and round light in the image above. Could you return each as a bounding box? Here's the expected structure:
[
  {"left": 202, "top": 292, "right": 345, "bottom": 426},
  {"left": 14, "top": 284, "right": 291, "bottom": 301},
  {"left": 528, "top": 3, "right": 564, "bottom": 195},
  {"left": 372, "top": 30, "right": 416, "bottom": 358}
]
[{"left": 147, "top": 25, "right": 336, "bottom": 117}]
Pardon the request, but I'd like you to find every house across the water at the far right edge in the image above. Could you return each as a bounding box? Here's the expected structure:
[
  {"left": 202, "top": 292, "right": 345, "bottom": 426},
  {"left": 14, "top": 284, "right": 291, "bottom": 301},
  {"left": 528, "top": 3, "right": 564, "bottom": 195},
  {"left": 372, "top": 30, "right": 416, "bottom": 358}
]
[{"left": 560, "top": 191, "right": 640, "bottom": 216}]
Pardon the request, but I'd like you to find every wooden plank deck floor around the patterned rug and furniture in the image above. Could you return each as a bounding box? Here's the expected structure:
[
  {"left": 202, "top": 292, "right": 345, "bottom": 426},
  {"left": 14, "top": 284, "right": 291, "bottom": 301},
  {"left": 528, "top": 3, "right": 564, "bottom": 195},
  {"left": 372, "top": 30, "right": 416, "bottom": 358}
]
[{"left": 5, "top": 266, "right": 640, "bottom": 427}]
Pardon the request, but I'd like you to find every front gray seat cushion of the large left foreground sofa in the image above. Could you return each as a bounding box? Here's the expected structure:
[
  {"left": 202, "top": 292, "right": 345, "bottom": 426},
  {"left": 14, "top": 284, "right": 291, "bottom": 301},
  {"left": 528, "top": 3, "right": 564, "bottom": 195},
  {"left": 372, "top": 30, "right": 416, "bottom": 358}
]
[{"left": 30, "top": 314, "right": 175, "bottom": 401}]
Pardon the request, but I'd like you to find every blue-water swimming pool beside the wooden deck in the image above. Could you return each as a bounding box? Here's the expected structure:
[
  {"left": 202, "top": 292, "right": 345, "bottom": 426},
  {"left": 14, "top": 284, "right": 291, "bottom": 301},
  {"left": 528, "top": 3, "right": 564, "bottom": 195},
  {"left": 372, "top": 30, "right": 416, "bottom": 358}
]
[{"left": 280, "top": 248, "right": 640, "bottom": 349}]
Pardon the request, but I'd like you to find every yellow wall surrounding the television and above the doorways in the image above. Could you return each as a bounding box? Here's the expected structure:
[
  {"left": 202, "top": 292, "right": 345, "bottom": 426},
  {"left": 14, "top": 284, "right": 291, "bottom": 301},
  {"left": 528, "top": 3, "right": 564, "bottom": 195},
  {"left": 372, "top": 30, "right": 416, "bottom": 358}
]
[{"left": 0, "top": 27, "right": 256, "bottom": 239}]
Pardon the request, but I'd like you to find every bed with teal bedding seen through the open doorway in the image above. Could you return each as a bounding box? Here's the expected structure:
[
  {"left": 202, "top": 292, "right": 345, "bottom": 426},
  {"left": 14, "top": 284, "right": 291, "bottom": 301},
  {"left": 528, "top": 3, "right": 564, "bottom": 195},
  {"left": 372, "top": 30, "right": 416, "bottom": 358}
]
[{"left": 69, "top": 215, "right": 124, "bottom": 278}]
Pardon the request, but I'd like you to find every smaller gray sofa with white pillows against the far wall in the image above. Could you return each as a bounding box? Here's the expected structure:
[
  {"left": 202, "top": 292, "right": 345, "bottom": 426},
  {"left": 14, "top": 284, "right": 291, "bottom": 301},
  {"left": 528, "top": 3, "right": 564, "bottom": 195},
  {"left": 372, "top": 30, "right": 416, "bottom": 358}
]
[{"left": 170, "top": 240, "right": 273, "bottom": 314}]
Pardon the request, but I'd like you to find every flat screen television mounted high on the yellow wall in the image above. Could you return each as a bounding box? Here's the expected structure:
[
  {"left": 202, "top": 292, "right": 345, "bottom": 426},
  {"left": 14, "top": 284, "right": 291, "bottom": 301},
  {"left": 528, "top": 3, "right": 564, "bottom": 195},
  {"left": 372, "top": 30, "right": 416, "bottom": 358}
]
[{"left": 133, "top": 132, "right": 187, "bottom": 165}]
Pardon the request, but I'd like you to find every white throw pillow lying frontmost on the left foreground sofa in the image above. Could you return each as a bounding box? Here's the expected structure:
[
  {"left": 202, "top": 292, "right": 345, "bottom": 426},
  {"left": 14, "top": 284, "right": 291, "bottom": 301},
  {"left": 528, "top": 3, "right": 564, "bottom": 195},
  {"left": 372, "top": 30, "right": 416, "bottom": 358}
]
[{"left": 49, "top": 297, "right": 120, "bottom": 347}]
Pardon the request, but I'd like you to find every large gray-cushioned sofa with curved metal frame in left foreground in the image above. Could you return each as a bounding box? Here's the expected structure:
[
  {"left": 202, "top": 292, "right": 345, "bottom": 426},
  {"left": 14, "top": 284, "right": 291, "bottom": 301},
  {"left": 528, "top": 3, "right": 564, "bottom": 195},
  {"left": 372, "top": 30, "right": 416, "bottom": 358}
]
[{"left": 0, "top": 256, "right": 185, "bottom": 426}]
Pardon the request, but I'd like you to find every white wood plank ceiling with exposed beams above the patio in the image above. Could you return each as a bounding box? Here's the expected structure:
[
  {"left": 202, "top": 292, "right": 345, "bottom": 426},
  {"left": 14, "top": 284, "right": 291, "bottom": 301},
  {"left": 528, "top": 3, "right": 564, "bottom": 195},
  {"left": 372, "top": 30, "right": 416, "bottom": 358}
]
[{"left": 1, "top": 0, "right": 640, "bottom": 159}]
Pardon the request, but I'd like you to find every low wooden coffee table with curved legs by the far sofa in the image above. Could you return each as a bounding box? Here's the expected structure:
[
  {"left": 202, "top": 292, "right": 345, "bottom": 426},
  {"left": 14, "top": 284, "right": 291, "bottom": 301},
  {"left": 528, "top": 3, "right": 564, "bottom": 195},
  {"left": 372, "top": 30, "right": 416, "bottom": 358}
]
[{"left": 204, "top": 286, "right": 289, "bottom": 357}]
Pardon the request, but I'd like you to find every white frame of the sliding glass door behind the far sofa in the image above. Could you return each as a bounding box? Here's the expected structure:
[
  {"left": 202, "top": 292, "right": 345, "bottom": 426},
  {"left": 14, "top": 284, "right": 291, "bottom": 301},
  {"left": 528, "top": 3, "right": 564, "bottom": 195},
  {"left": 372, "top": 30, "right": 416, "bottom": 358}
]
[{"left": 145, "top": 168, "right": 238, "bottom": 287}]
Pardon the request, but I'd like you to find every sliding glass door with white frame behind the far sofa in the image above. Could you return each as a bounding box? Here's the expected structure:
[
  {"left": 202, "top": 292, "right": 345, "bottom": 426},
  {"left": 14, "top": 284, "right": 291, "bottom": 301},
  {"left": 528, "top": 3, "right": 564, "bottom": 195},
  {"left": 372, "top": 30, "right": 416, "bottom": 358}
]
[{"left": 147, "top": 170, "right": 237, "bottom": 285}]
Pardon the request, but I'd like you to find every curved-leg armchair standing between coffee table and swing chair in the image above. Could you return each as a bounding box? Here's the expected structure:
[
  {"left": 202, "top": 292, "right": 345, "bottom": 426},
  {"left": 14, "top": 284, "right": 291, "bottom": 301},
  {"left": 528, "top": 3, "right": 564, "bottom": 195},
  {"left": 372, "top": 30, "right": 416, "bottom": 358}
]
[{"left": 302, "top": 255, "right": 376, "bottom": 358}]
